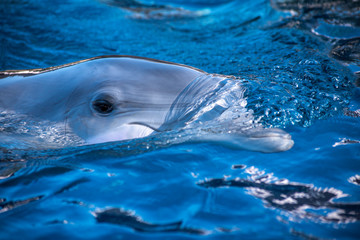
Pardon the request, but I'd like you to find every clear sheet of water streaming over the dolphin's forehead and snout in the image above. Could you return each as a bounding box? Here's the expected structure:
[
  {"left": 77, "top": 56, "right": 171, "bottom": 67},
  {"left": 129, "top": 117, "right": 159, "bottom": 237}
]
[{"left": 165, "top": 75, "right": 255, "bottom": 133}]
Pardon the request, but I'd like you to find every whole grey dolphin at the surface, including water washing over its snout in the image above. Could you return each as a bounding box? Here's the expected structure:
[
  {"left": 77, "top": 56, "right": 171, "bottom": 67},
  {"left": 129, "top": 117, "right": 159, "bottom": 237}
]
[{"left": 0, "top": 56, "right": 294, "bottom": 152}]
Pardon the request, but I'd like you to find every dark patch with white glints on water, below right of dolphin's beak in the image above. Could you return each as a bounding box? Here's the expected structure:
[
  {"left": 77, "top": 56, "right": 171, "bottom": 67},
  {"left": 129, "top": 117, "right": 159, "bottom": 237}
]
[{"left": 198, "top": 167, "right": 360, "bottom": 223}]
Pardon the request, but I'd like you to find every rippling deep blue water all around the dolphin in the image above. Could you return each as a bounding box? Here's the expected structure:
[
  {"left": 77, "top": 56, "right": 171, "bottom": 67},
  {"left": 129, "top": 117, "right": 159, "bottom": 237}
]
[{"left": 0, "top": 0, "right": 360, "bottom": 239}]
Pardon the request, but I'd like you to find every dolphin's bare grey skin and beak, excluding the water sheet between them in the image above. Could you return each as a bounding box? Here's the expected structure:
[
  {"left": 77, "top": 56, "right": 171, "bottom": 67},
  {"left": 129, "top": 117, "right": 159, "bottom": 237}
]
[{"left": 0, "top": 55, "right": 293, "bottom": 152}]
